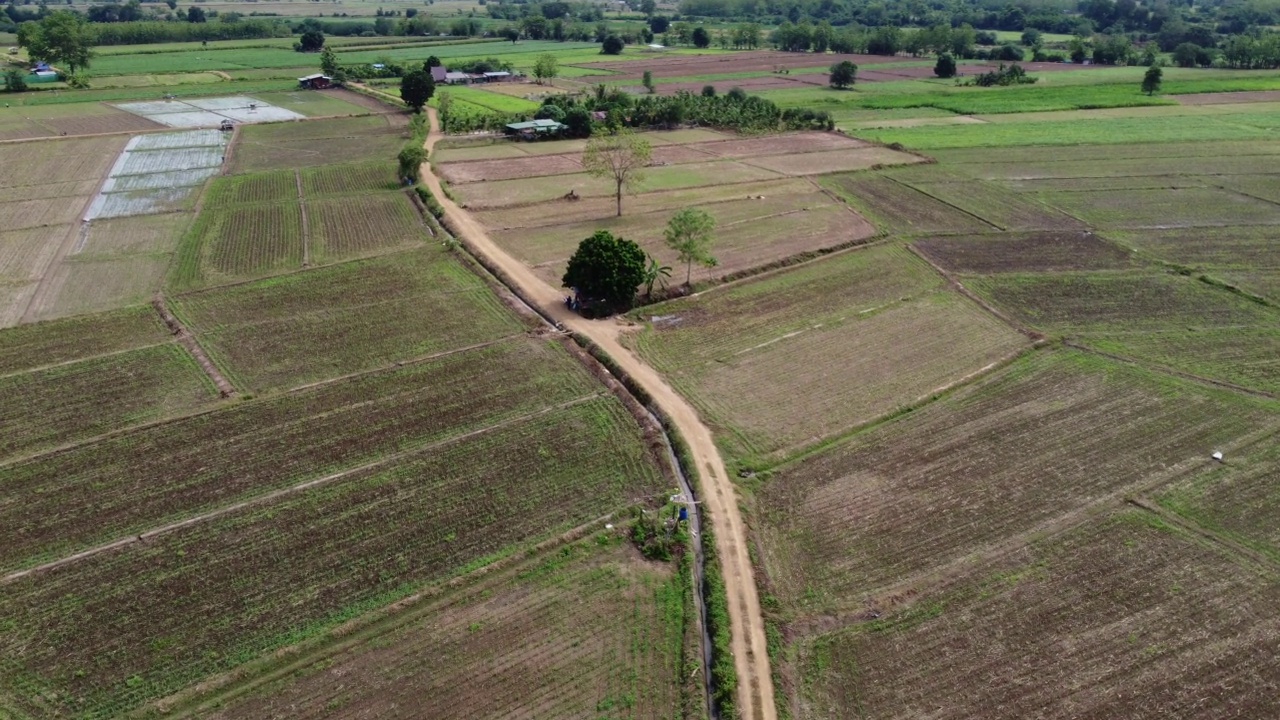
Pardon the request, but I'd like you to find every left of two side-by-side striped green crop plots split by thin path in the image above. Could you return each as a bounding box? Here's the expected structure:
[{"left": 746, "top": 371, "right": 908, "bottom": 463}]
[{"left": 204, "top": 204, "right": 302, "bottom": 277}]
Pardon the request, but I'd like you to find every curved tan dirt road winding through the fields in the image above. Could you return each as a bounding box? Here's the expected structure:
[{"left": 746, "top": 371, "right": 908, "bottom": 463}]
[{"left": 421, "top": 109, "right": 777, "bottom": 720}]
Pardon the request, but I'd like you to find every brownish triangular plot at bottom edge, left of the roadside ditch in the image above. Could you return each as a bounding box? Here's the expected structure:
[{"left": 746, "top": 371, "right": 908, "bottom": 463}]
[{"left": 197, "top": 534, "right": 691, "bottom": 720}]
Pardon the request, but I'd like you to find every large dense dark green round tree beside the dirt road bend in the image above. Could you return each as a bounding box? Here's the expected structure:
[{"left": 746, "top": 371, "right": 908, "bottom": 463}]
[{"left": 562, "top": 231, "right": 646, "bottom": 310}]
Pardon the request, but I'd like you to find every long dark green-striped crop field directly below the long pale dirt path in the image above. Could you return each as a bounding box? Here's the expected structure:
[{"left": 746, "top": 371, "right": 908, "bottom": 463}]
[{"left": 0, "top": 398, "right": 664, "bottom": 717}]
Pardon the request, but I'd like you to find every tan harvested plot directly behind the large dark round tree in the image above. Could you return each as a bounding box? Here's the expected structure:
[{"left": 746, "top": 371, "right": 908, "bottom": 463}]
[{"left": 493, "top": 193, "right": 876, "bottom": 284}]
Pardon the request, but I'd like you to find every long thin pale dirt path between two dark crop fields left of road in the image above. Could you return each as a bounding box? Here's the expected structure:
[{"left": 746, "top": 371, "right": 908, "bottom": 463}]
[{"left": 0, "top": 392, "right": 604, "bottom": 585}]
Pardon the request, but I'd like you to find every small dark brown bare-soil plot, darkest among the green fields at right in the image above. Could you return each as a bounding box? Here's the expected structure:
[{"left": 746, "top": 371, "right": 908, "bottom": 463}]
[{"left": 915, "top": 232, "right": 1135, "bottom": 273}]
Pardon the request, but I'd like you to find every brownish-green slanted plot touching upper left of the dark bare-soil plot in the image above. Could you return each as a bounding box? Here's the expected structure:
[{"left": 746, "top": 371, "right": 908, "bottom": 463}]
[{"left": 819, "top": 173, "right": 993, "bottom": 234}]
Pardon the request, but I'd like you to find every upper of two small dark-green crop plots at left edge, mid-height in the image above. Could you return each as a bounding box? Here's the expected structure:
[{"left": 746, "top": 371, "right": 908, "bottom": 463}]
[{"left": 0, "top": 302, "right": 169, "bottom": 375}]
